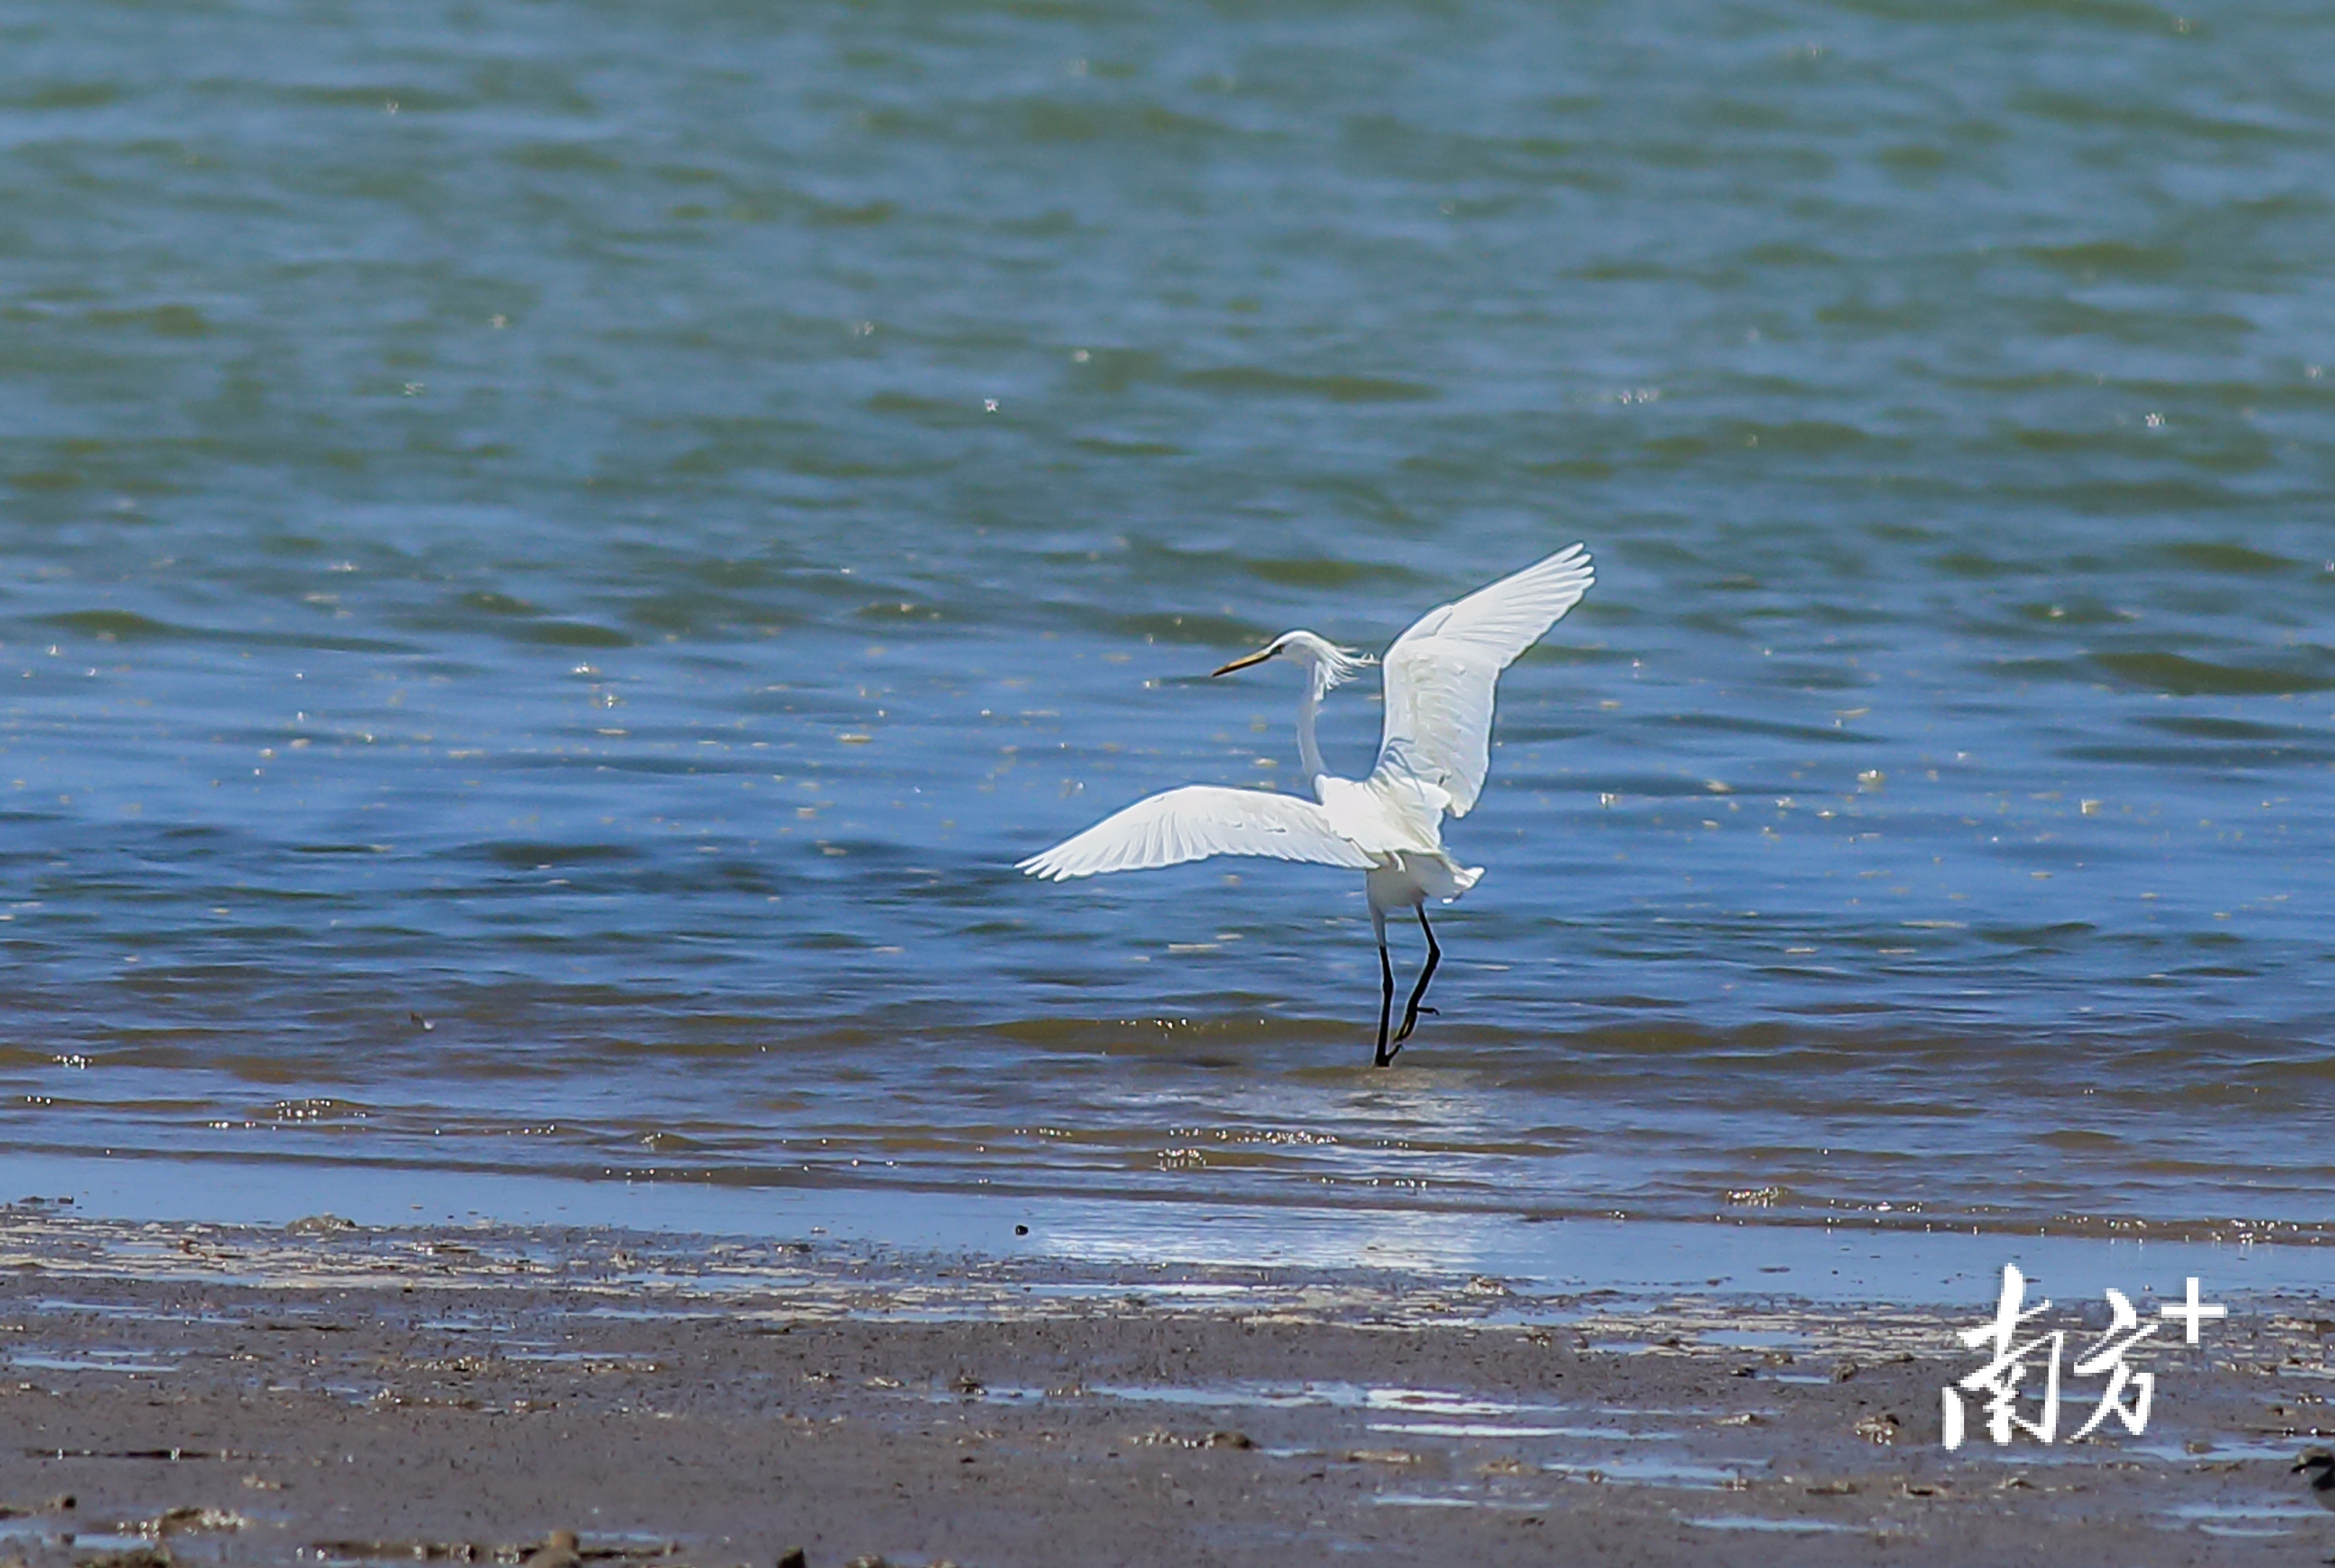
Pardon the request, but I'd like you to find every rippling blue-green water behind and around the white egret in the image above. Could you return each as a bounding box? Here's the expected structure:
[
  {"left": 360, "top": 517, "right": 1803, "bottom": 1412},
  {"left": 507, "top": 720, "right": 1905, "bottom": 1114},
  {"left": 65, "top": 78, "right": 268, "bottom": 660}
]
[{"left": 0, "top": 0, "right": 2335, "bottom": 1234}]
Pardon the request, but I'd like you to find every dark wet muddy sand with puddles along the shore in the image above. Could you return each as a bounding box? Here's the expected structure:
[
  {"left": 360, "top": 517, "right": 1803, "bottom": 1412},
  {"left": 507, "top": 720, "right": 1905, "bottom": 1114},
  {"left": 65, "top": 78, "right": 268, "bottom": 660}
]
[{"left": 0, "top": 1209, "right": 2335, "bottom": 1568}]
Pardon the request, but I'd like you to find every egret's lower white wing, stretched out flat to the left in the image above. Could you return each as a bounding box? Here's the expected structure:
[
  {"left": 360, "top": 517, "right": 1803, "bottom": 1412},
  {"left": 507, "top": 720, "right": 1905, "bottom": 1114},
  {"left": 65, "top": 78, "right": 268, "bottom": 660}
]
[{"left": 1020, "top": 784, "right": 1375, "bottom": 882}]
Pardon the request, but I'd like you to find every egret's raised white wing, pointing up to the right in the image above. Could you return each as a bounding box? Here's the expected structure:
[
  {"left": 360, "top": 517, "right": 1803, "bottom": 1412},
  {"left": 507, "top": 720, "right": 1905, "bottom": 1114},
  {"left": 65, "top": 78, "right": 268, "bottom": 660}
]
[{"left": 1378, "top": 544, "right": 1595, "bottom": 817}]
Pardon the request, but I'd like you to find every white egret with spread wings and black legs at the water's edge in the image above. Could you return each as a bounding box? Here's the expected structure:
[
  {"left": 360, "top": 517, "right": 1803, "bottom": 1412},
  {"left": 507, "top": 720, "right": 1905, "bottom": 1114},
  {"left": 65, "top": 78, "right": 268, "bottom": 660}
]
[{"left": 1020, "top": 544, "right": 1595, "bottom": 1066}]
